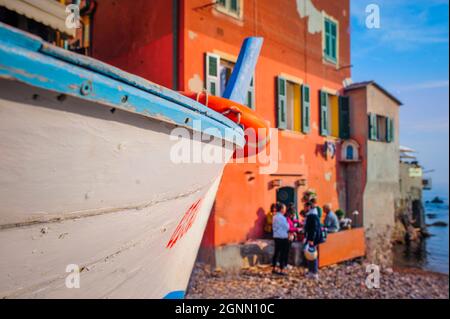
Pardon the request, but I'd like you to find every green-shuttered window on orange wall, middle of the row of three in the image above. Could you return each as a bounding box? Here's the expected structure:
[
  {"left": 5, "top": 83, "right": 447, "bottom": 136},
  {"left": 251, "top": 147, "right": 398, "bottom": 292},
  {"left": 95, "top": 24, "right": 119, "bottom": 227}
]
[{"left": 277, "top": 77, "right": 304, "bottom": 133}]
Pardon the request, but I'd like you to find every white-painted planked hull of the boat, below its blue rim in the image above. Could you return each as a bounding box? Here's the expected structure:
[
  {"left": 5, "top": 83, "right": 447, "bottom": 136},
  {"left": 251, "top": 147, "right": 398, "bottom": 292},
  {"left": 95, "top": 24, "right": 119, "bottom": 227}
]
[{"left": 0, "top": 79, "right": 232, "bottom": 298}]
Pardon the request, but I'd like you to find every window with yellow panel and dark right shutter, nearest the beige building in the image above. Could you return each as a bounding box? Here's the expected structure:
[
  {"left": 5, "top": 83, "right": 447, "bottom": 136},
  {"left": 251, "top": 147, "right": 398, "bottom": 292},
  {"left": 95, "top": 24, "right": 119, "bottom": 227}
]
[{"left": 320, "top": 91, "right": 350, "bottom": 139}]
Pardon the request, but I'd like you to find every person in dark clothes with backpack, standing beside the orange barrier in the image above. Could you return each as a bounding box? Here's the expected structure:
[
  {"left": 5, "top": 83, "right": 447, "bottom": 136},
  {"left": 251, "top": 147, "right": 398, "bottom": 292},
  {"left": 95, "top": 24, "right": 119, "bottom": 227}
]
[{"left": 305, "top": 202, "right": 322, "bottom": 279}]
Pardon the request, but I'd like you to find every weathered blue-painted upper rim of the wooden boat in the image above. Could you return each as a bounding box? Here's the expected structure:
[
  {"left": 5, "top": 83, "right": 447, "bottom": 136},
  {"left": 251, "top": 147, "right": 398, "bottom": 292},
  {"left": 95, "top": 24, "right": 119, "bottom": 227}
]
[{"left": 0, "top": 24, "right": 245, "bottom": 147}]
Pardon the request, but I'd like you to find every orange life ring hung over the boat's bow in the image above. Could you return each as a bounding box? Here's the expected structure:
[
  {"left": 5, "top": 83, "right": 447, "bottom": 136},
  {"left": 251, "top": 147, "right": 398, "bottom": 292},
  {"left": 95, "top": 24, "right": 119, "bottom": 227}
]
[{"left": 179, "top": 92, "right": 270, "bottom": 157}]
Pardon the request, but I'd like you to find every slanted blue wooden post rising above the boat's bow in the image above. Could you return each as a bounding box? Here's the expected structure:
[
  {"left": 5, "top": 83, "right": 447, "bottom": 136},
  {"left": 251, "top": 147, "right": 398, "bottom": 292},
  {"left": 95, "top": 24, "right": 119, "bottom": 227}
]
[{"left": 223, "top": 37, "right": 263, "bottom": 104}]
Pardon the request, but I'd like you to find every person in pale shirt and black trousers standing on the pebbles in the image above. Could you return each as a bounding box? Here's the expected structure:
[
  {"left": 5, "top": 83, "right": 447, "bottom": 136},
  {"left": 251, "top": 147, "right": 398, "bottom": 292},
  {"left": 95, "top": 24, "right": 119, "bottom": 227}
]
[{"left": 272, "top": 203, "right": 289, "bottom": 275}]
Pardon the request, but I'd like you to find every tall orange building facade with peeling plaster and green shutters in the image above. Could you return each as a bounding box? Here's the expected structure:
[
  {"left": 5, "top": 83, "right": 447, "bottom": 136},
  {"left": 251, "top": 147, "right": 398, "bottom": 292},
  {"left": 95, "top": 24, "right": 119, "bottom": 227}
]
[{"left": 93, "top": 0, "right": 351, "bottom": 249}]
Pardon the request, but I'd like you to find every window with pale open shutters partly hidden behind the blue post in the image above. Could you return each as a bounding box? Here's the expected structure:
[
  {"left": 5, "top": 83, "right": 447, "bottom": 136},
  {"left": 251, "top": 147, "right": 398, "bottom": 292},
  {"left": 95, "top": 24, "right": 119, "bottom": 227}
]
[{"left": 205, "top": 53, "right": 255, "bottom": 109}]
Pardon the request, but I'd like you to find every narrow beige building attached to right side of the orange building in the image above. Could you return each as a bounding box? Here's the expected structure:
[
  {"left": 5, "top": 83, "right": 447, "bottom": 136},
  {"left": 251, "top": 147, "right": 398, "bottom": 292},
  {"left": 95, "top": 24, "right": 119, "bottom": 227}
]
[{"left": 341, "top": 81, "right": 402, "bottom": 265}]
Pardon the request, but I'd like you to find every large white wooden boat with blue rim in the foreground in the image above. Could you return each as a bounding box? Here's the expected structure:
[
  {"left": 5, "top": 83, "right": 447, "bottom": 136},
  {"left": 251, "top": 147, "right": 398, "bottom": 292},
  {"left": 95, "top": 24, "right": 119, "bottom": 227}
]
[{"left": 0, "top": 24, "right": 264, "bottom": 298}]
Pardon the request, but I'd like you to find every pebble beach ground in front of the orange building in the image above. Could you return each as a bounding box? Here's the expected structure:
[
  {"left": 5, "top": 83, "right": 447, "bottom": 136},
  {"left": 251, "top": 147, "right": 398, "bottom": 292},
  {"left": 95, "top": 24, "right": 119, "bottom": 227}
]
[{"left": 186, "top": 261, "right": 449, "bottom": 299}]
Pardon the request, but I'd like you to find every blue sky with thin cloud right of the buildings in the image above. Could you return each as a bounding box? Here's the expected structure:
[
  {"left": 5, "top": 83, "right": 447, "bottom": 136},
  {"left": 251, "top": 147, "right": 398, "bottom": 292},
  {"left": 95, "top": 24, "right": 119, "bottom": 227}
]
[{"left": 351, "top": 0, "right": 449, "bottom": 193}]
